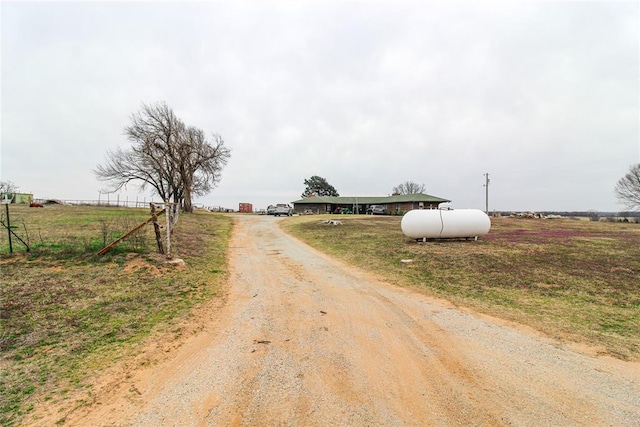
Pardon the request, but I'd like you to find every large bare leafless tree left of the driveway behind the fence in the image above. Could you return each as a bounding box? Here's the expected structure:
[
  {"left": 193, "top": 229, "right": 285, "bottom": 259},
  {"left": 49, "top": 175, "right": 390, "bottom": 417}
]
[{"left": 94, "top": 102, "right": 231, "bottom": 212}]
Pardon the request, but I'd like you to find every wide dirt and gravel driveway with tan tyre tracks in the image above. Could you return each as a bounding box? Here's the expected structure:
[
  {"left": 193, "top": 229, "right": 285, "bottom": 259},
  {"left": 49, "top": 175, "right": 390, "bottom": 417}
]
[{"left": 47, "top": 216, "right": 640, "bottom": 426}]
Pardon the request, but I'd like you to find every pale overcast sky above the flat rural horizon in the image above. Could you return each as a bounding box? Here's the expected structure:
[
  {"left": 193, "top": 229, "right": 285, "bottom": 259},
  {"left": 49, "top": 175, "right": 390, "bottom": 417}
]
[{"left": 0, "top": 1, "right": 640, "bottom": 211}]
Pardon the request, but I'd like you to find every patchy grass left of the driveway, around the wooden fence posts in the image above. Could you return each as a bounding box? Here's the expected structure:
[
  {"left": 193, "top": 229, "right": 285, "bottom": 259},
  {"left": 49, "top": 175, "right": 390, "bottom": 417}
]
[{"left": 0, "top": 206, "right": 232, "bottom": 425}]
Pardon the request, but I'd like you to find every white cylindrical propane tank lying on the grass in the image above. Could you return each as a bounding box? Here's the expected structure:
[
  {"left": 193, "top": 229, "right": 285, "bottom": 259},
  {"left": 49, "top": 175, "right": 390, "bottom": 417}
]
[{"left": 400, "top": 209, "right": 491, "bottom": 239}]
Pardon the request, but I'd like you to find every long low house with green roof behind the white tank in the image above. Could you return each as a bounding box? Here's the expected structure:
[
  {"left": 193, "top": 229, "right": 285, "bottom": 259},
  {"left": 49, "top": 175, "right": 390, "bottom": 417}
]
[{"left": 292, "top": 193, "right": 451, "bottom": 215}]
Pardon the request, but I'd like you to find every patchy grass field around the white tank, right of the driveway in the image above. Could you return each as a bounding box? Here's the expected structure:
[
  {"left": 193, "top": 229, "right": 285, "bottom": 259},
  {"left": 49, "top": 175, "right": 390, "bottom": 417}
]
[{"left": 281, "top": 216, "right": 640, "bottom": 360}]
